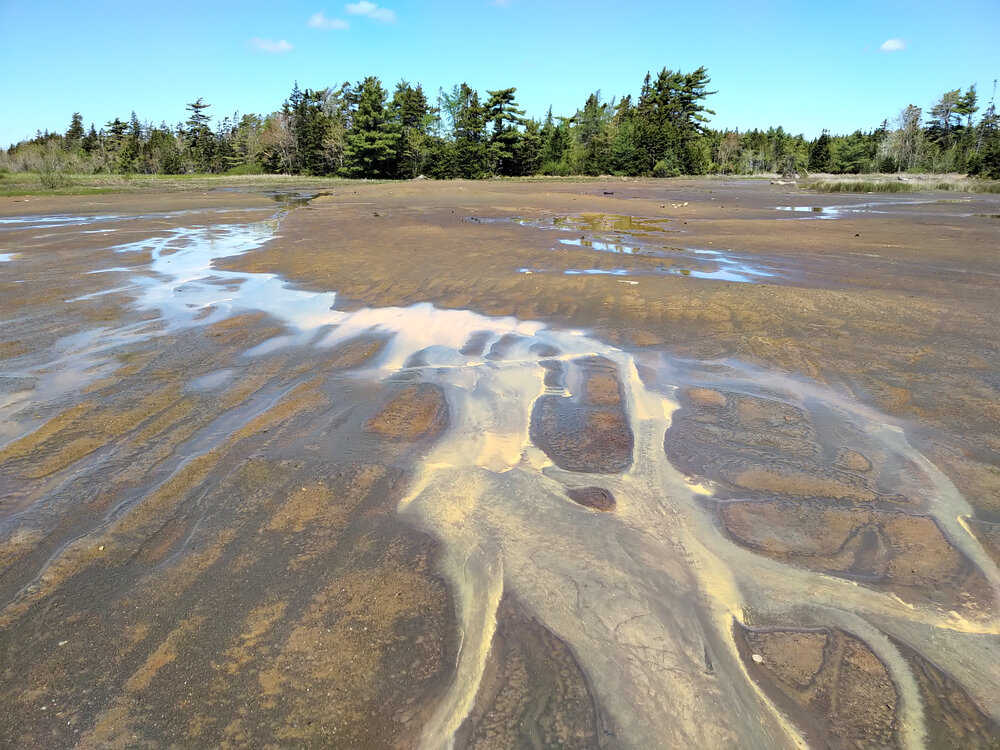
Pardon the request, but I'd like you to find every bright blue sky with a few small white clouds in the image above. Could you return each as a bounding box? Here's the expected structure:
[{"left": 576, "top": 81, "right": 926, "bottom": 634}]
[{"left": 0, "top": 0, "right": 1000, "bottom": 147}]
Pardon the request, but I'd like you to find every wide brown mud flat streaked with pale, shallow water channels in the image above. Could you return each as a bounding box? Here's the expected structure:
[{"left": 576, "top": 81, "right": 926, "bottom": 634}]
[{"left": 0, "top": 180, "right": 1000, "bottom": 748}]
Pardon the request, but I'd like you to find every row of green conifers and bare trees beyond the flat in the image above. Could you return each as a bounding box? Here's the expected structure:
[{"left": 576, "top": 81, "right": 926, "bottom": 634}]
[{"left": 0, "top": 67, "right": 1000, "bottom": 179}]
